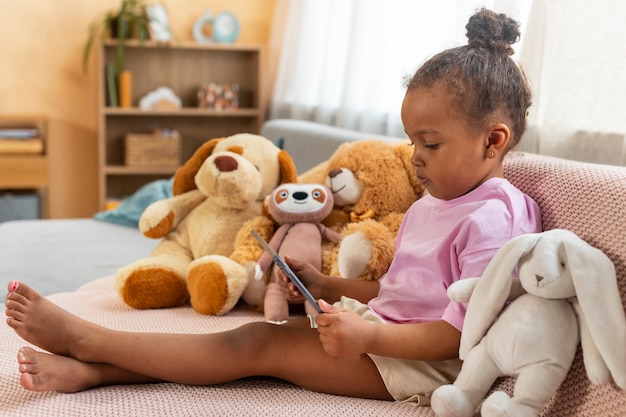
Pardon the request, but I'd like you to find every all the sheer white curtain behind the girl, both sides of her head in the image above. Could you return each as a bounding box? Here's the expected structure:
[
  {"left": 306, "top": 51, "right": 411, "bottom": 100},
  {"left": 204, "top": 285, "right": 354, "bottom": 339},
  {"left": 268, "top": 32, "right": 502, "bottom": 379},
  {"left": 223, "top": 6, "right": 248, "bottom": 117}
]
[{"left": 270, "top": 0, "right": 626, "bottom": 165}]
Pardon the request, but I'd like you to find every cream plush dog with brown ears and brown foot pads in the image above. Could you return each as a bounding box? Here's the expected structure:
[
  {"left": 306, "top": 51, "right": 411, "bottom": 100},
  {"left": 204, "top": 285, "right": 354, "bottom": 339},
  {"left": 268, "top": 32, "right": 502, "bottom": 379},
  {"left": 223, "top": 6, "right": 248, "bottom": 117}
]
[{"left": 116, "top": 133, "right": 296, "bottom": 315}]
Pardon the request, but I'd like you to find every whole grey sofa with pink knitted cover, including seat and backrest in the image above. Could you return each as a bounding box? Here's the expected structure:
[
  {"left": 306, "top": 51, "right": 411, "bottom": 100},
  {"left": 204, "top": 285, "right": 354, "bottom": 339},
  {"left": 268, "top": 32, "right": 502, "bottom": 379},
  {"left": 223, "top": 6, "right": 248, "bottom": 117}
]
[{"left": 0, "top": 120, "right": 626, "bottom": 417}]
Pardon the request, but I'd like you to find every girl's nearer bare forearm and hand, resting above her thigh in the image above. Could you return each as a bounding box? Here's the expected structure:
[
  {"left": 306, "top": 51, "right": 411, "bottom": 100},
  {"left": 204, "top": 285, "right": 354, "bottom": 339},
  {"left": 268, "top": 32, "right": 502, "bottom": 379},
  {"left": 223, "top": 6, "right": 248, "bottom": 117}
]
[{"left": 315, "top": 301, "right": 461, "bottom": 361}]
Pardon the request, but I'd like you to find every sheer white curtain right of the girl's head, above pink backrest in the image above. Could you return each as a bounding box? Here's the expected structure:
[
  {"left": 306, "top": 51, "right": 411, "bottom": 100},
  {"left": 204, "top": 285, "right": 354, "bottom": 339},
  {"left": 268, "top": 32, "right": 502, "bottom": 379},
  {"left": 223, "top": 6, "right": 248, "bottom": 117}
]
[{"left": 520, "top": 0, "right": 626, "bottom": 165}]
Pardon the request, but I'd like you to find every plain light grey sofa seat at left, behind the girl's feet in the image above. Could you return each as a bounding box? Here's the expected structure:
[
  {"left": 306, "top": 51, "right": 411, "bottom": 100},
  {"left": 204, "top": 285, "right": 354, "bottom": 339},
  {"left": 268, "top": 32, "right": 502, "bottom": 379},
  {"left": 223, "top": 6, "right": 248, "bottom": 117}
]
[{"left": 0, "top": 219, "right": 159, "bottom": 300}]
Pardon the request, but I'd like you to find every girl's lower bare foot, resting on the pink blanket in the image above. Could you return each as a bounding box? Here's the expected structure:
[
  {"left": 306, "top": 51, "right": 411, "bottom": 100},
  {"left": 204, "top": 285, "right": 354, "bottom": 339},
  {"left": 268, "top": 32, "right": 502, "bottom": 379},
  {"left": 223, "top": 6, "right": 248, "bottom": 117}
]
[{"left": 17, "top": 347, "right": 99, "bottom": 392}]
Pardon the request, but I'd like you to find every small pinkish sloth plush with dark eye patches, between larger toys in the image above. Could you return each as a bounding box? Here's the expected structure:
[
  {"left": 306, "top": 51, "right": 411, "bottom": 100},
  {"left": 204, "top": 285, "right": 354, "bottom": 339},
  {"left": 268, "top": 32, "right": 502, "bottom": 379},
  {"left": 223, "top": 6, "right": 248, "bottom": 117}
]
[{"left": 255, "top": 183, "right": 341, "bottom": 323}]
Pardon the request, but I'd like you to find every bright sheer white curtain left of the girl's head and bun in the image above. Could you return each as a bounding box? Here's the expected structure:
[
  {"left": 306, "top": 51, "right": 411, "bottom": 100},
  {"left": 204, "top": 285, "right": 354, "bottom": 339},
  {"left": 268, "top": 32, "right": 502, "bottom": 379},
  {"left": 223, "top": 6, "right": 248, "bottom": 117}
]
[{"left": 270, "top": 0, "right": 531, "bottom": 136}]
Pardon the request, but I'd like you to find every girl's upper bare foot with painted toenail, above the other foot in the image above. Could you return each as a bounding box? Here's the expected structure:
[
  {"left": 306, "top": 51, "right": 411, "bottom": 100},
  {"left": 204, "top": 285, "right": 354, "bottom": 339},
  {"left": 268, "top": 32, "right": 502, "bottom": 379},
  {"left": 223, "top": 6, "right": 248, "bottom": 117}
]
[{"left": 5, "top": 281, "right": 96, "bottom": 359}]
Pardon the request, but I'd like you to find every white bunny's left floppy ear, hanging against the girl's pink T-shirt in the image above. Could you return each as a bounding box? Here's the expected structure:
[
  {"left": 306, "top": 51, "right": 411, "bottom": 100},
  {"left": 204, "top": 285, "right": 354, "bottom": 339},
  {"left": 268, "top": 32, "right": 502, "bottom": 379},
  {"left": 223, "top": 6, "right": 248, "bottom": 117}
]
[{"left": 459, "top": 233, "right": 541, "bottom": 359}]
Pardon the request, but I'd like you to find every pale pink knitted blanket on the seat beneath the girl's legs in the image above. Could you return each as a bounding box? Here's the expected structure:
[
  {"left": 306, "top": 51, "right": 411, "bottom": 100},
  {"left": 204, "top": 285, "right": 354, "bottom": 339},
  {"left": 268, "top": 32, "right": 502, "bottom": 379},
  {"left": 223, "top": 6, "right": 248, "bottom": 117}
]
[{"left": 0, "top": 277, "right": 432, "bottom": 417}]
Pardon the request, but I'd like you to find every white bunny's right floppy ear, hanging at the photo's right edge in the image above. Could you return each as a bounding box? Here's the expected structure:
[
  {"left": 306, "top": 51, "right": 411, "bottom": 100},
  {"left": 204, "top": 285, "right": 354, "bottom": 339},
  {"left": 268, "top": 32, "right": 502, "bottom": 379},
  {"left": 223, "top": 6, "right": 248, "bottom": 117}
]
[{"left": 564, "top": 233, "right": 626, "bottom": 389}]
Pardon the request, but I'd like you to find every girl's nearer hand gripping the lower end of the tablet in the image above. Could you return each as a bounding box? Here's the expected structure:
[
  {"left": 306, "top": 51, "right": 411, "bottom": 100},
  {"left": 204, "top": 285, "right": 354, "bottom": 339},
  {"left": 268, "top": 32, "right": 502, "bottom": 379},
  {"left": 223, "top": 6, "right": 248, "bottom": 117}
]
[{"left": 315, "top": 300, "right": 376, "bottom": 356}]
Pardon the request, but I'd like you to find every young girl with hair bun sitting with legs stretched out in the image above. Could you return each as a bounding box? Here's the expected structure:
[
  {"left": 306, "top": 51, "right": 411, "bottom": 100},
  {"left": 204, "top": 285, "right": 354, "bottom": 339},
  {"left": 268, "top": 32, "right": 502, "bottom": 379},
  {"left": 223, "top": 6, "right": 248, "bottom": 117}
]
[{"left": 6, "top": 9, "right": 541, "bottom": 405}]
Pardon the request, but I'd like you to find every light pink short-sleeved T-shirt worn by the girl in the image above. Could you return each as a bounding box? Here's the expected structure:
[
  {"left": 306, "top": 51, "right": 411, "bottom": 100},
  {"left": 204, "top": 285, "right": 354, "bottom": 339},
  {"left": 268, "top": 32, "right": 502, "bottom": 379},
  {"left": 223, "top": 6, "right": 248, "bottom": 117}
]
[{"left": 368, "top": 178, "right": 541, "bottom": 330}]
